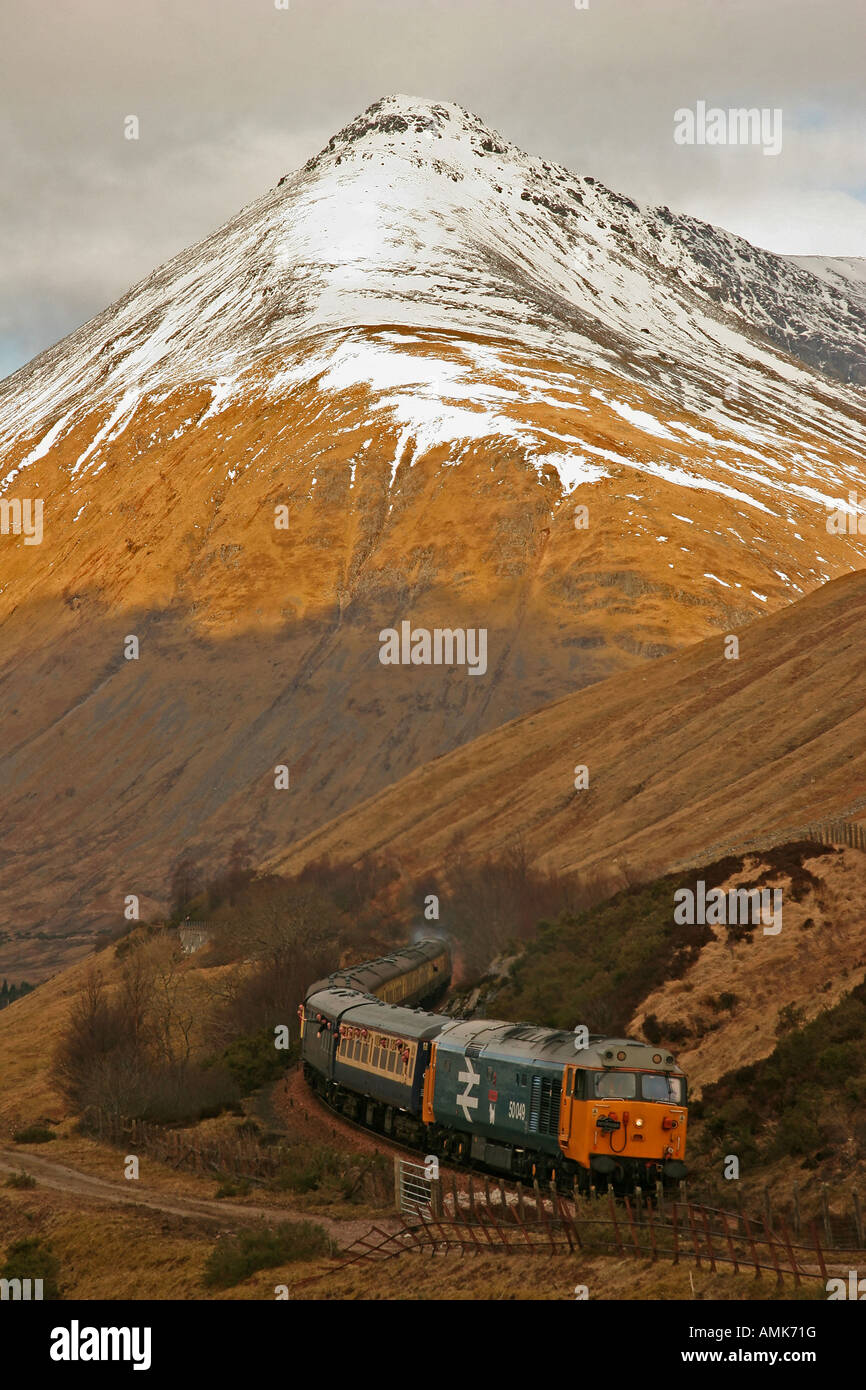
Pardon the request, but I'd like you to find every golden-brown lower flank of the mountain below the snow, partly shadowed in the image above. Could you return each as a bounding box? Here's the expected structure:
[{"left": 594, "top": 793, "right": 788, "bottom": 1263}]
[{"left": 0, "top": 329, "right": 865, "bottom": 979}]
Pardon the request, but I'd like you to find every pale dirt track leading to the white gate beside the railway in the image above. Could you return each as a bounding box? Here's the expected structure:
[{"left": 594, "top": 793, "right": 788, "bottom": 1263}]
[{"left": 0, "top": 1148, "right": 399, "bottom": 1248}]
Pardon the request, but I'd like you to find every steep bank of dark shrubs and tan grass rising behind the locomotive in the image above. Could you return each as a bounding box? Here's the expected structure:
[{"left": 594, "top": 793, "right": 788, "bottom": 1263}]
[{"left": 484, "top": 841, "right": 866, "bottom": 1094}]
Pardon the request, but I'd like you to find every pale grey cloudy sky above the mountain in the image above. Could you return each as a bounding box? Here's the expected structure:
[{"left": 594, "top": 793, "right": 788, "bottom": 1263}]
[{"left": 0, "top": 0, "right": 866, "bottom": 377}]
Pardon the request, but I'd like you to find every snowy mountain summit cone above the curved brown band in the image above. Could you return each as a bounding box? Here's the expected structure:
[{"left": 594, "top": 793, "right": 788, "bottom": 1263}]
[{"left": 0, "top": 93, "right": 866, "bottom": 469}]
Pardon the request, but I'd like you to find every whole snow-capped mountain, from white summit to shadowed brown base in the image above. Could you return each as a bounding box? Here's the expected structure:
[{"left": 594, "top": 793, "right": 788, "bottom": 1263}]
[{"left": 0, "top": 97, "right": 866, "bottom": 963}]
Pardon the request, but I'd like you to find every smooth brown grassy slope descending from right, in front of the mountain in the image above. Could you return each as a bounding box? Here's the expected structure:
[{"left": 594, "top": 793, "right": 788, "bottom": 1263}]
[{"left": 274, "top": 571, "right": 866, "bottom": 883}]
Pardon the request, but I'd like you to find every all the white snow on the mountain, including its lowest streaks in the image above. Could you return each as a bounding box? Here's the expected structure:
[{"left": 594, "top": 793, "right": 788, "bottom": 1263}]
[{"left": 0, "top": 97, "right": 866, "bottom": 525}]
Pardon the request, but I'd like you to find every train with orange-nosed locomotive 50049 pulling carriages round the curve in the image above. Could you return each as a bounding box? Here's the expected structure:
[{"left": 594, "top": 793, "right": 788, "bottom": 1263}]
[{"left": 300, "top": 941, "right": 687, "bottom": 1188}]
